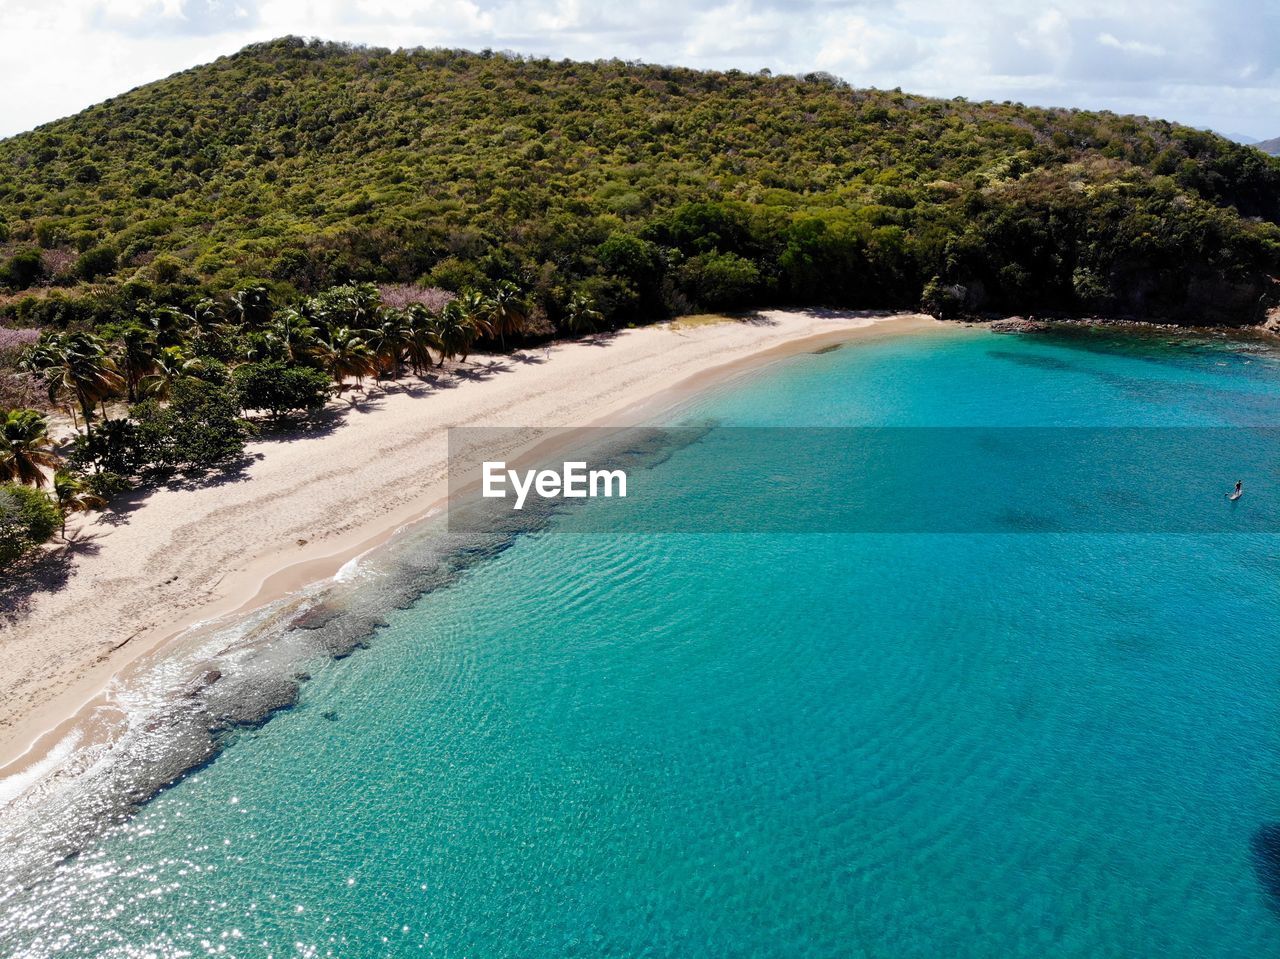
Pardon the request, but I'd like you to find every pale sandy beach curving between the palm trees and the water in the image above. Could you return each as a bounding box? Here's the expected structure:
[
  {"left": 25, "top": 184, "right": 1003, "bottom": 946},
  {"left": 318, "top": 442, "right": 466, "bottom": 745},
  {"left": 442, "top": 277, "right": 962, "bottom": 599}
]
[{"left": 0, "top": 311, "right": 936, "bottom": 776}]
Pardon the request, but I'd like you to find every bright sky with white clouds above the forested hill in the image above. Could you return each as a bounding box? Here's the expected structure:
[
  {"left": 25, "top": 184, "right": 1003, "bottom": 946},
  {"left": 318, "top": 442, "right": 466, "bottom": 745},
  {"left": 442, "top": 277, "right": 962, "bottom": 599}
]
[{"left": 0, "top": 0, "right": 1280, "bottom": 140}]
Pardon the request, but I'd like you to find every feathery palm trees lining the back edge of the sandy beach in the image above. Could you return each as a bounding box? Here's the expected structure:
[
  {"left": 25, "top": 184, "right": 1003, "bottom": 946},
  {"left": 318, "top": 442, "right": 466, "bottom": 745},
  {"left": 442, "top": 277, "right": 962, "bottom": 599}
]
[{"left": 0, "top": 282, "right": 586, "bottom": 560}]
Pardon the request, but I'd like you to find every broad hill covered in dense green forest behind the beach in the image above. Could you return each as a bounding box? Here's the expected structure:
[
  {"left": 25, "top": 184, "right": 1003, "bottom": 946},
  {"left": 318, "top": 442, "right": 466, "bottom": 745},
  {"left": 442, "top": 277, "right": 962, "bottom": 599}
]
[{"left": 0, "top": 38, "right": 1280, "bottom": 325}]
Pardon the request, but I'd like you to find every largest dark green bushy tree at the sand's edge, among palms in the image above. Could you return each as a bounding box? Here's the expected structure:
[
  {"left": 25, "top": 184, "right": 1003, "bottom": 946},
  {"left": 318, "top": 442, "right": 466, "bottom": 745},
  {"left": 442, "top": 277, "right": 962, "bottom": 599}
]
[{"left": 129, "top": 379, "right": 250, "bottom": 474}]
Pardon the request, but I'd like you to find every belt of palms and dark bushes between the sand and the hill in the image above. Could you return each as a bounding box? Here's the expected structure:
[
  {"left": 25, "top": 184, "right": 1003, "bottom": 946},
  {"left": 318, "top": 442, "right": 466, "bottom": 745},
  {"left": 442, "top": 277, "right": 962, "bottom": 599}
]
[{"left": 0, "top": 280, "right": 547, "bottom": 567}]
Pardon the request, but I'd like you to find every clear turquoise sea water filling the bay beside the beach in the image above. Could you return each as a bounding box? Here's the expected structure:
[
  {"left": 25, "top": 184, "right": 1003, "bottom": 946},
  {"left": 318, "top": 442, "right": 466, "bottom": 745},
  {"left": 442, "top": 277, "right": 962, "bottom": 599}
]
[{"left": 0, "top": 329, "right": 1280, "bottom": 959}]
